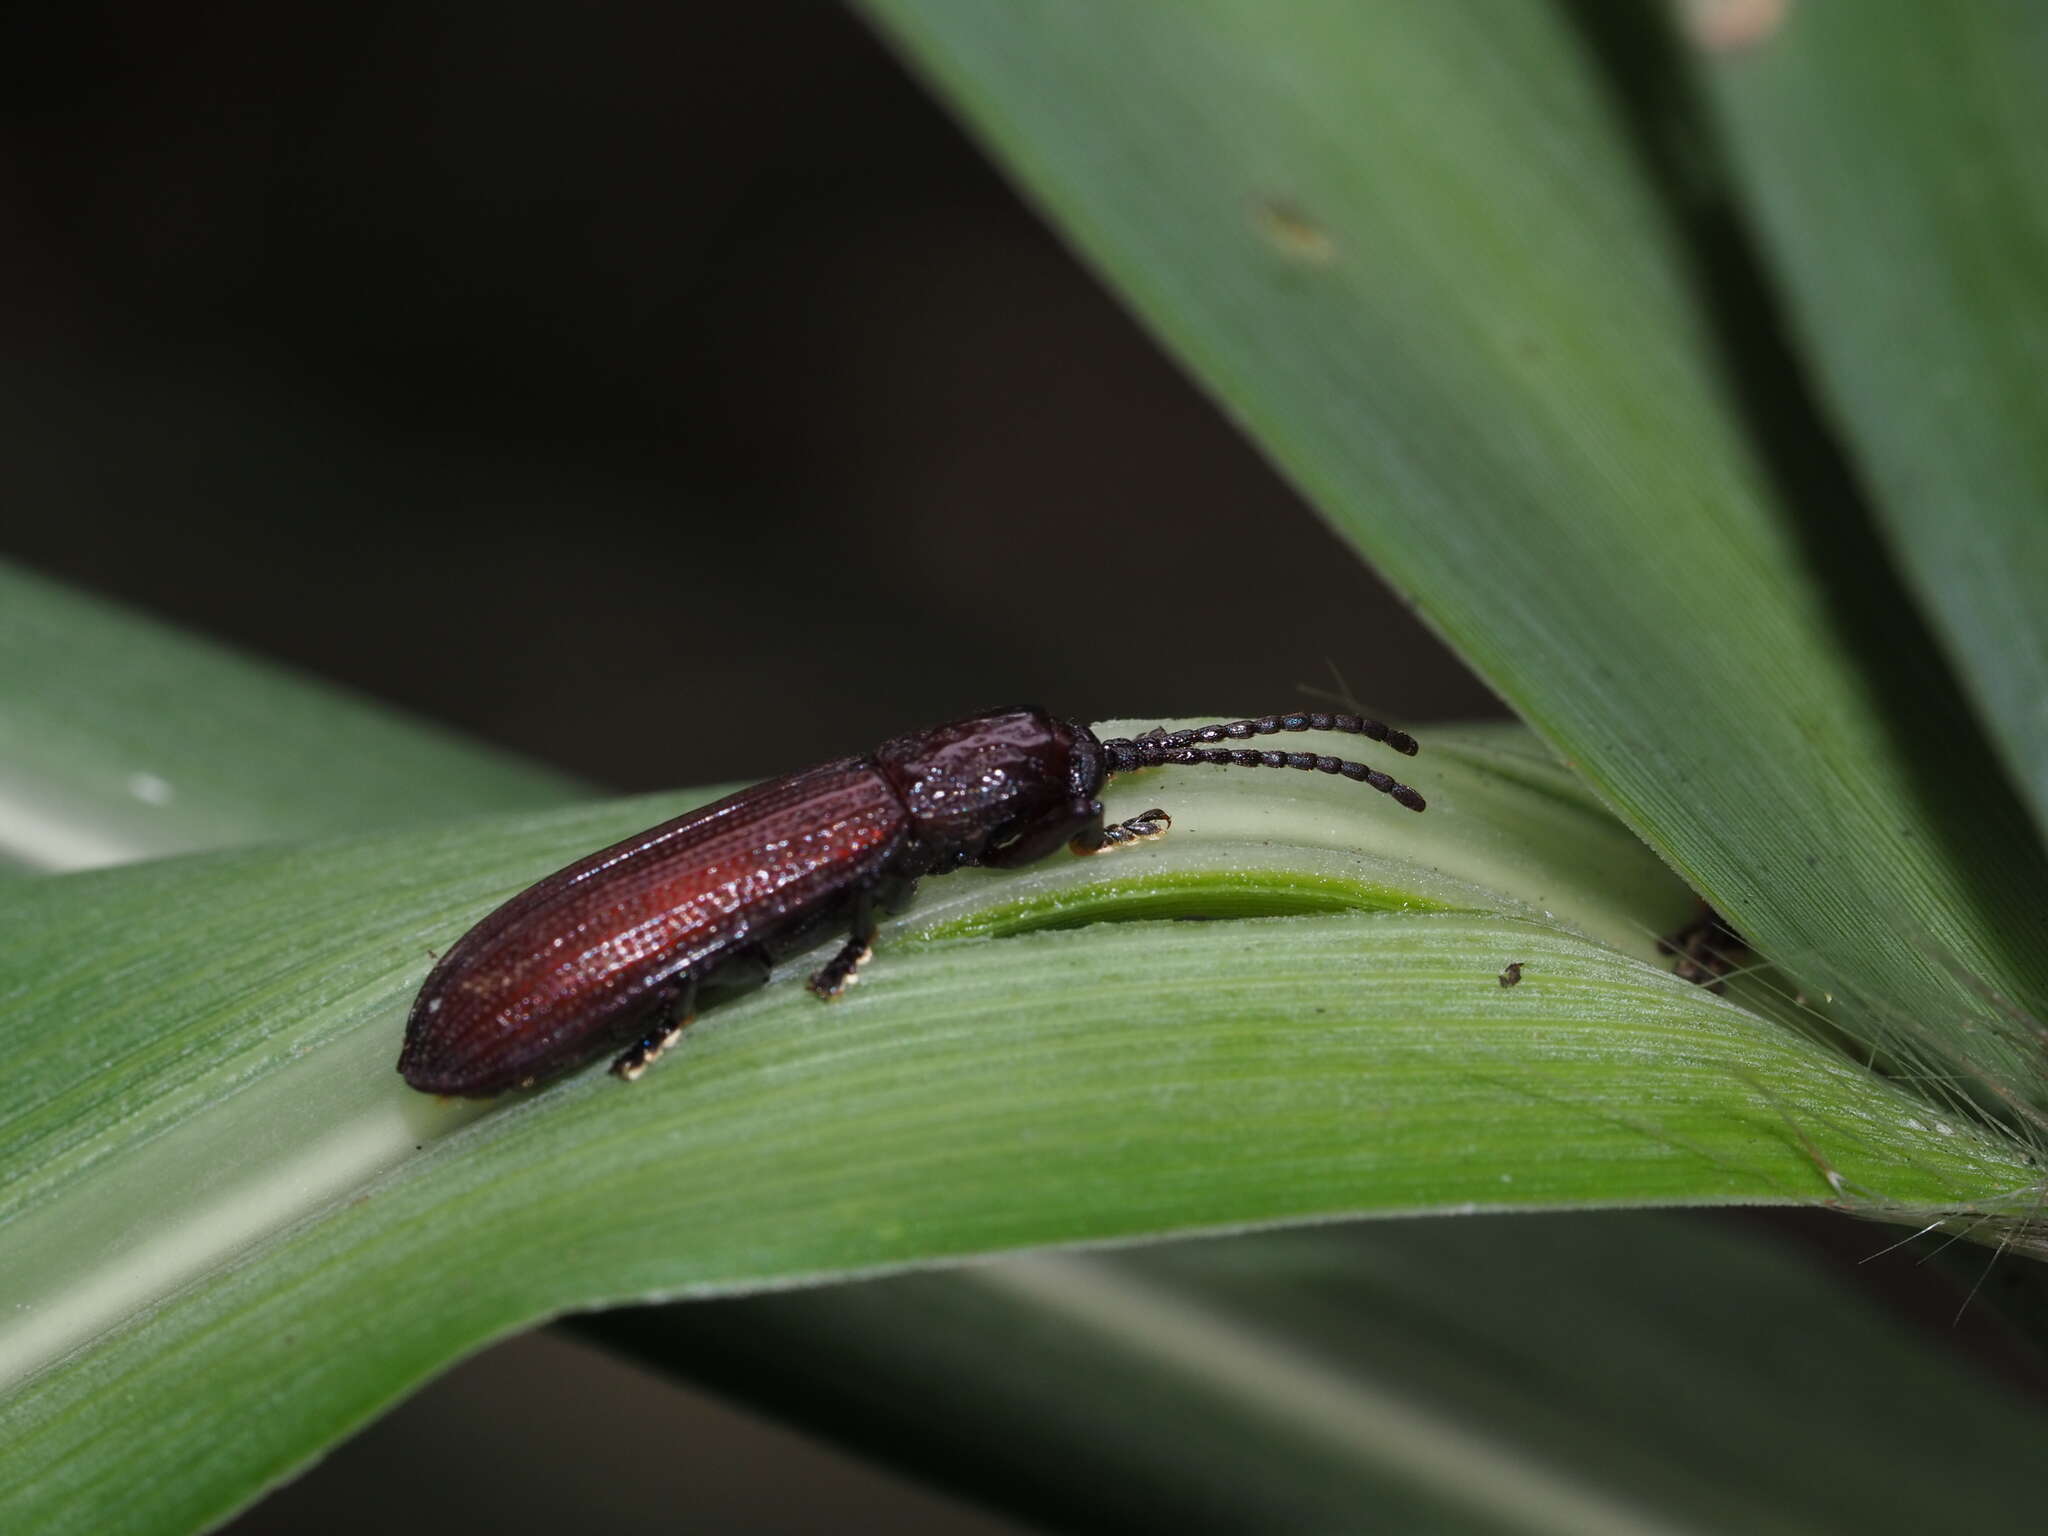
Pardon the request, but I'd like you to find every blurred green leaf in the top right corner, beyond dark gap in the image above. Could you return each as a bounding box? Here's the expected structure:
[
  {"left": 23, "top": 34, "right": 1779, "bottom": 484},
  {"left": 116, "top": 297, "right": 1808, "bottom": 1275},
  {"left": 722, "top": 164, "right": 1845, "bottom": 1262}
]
[{"left": 1694, "top": 0, "right": 2048, "bottom": 843}]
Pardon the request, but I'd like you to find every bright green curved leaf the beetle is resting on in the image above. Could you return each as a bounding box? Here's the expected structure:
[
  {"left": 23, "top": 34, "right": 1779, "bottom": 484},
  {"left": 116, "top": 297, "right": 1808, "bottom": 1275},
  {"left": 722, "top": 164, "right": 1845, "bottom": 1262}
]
[{"left": 0, "top": 741, "right": 2028, "bottom": 1530}]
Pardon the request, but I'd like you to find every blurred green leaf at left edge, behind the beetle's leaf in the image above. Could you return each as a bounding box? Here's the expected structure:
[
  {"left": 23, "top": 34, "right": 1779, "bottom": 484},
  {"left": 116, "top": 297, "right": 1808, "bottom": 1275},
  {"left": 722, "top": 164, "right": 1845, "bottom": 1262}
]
[{"left": 0, "top": 567, "right": 578, "bottom": 870}]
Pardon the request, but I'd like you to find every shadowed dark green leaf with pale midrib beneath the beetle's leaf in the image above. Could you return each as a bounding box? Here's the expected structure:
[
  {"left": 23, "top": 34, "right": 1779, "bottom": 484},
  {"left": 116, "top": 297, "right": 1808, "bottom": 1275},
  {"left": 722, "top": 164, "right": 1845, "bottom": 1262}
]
[{"left": 575, "top": 1212, "right": 2040, "bottom": 1534}]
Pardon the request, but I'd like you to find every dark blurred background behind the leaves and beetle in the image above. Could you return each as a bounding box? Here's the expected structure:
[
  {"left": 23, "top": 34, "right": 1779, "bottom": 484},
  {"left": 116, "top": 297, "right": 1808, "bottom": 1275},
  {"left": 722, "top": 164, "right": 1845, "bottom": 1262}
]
[{"left": 0, "top": 0, "right": 2031, "bottom": 1536}]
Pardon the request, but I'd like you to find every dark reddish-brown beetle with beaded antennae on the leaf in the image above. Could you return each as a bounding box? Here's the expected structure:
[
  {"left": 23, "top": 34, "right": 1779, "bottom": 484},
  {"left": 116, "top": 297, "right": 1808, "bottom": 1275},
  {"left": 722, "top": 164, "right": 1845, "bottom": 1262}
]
[{"left": 397, "top": 709, "right": 1423, "bottom": 1098}]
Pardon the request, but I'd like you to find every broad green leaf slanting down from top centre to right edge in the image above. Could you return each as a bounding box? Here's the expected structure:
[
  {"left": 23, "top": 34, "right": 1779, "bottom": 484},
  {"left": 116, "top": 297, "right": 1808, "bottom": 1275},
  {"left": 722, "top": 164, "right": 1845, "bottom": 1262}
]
[{"left": 866, "top": 0, "right": 2048, "bottom": 1104}]
